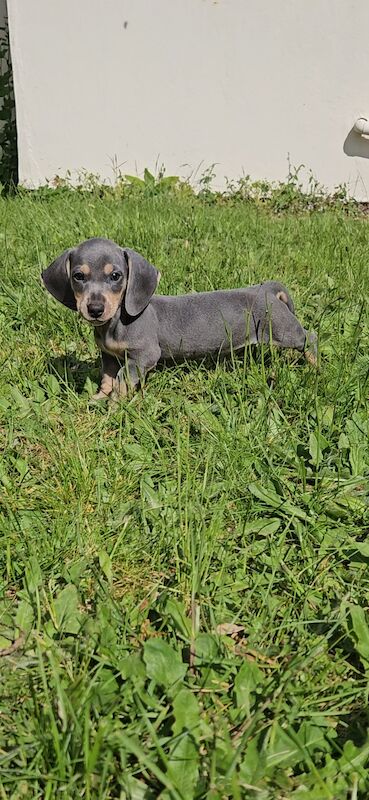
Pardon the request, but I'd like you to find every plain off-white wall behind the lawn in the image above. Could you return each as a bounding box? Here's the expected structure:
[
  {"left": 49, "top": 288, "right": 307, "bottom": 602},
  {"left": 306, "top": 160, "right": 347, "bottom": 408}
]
[{"left": 8, "top": 0, "right": 369, "bottom": 198}]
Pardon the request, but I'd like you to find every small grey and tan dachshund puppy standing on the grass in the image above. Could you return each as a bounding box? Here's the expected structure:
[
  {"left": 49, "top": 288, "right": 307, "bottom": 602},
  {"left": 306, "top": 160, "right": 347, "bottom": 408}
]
[{"left": 42, "top": 239, "right": 316, "bottom": 399}]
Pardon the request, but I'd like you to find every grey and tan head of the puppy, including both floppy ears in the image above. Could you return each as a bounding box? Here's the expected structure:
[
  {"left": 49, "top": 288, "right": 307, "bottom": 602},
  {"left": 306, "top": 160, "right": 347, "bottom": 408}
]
[{"left": 42, "top": 239, "right": 160, "bottom": 327}]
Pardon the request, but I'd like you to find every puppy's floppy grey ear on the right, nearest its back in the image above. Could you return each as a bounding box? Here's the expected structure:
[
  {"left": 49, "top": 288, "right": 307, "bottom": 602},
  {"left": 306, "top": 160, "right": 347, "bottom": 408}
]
[{"left": 124, "top": 248, "right": 160, "bottom": 317}]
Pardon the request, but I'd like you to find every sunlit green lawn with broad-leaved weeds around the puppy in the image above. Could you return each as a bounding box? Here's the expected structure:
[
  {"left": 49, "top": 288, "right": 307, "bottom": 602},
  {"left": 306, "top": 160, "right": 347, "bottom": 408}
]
[{"left": 0, "top": 178, "right": 369, "bottom": 800}]
